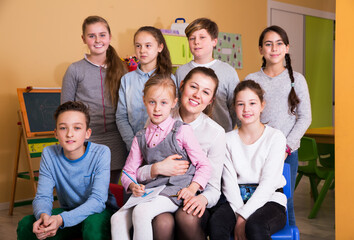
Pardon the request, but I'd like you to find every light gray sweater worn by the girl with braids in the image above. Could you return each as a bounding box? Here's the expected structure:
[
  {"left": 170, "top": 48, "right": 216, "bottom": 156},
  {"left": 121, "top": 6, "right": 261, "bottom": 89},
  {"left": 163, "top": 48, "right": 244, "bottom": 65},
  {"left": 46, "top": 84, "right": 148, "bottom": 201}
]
[{"left": 245, "top": 69, "right": 312, "bottom": 151}]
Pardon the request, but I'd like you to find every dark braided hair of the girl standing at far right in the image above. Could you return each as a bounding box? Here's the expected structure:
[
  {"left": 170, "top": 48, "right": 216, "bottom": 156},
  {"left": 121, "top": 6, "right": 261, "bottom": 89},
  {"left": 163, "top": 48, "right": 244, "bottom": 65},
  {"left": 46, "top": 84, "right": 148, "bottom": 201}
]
[{"left": 258, "top": 25, "right": 300, "bottom": 115}]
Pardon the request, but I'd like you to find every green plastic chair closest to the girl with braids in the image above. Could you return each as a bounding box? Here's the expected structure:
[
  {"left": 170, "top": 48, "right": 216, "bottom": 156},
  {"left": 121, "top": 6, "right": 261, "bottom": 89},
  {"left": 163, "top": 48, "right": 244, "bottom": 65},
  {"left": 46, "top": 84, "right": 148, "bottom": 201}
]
[{"left": 295, "top": 137, "right": 334, "bottom": 218}]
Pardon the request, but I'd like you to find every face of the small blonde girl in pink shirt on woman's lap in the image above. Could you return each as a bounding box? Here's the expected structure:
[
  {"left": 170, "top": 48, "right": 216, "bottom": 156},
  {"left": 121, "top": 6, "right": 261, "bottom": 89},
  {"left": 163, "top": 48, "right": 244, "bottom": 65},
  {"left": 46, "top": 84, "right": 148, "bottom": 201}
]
[{"left": 143, "top": 85, "right": 178, "bottom": 125}]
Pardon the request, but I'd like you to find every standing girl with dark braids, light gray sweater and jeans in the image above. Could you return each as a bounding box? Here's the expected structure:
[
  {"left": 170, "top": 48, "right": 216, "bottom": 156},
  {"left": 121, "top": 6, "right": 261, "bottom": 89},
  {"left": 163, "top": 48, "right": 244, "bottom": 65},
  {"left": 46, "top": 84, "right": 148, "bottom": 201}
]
[{"left": 246, "top": 26, "right": 311, "bottom": 225}]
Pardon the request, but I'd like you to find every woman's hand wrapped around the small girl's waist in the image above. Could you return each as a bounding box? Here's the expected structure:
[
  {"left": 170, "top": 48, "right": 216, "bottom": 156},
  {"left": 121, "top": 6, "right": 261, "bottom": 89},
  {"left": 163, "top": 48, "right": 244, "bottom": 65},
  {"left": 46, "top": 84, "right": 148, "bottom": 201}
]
[{"left": 151, "top": 154, "right": 189, "bottom": 178}]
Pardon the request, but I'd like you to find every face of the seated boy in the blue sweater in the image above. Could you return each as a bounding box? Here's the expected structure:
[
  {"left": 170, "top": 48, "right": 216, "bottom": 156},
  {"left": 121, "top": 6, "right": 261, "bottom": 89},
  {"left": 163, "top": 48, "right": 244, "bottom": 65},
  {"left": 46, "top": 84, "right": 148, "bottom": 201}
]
[{"left": 54, "top": 111, "right": 91, "bottom": 160}]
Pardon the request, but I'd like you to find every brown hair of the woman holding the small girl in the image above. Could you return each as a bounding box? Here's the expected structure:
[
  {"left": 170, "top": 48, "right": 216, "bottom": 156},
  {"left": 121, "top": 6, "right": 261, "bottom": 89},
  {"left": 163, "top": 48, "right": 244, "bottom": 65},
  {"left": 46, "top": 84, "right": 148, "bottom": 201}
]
[{"left": 179, "top": 67, "right": 219, "bottom": 117}]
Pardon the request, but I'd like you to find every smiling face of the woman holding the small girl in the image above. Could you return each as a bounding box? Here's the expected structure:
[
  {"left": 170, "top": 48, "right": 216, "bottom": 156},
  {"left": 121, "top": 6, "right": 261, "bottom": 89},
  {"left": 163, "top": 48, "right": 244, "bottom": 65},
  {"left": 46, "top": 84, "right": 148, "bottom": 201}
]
[{"left": 181, "top": 72, "right": 216, "bottom": 122}]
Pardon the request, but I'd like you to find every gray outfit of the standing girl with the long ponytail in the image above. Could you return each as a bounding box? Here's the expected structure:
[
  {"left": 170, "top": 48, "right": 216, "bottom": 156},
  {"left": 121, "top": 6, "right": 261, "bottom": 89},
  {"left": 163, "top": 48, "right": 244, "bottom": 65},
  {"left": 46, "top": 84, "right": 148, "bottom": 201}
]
[{"left": 61, "top": 58, "right": 127, "bottom": 170}]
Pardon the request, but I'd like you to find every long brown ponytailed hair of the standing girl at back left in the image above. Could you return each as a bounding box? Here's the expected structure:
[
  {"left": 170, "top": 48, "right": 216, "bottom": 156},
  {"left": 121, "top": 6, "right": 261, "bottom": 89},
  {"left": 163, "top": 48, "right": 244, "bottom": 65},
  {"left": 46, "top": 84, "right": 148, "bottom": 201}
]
[{"left": 82, "top": 16, "right": 128, "bottom": 108}]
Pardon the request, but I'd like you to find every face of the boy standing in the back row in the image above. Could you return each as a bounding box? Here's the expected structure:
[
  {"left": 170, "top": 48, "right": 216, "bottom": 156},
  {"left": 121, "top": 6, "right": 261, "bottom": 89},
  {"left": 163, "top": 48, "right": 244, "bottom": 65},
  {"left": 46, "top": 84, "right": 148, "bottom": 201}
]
[{"left": 188, "top": 29, "right": 218, "bottom": 64}]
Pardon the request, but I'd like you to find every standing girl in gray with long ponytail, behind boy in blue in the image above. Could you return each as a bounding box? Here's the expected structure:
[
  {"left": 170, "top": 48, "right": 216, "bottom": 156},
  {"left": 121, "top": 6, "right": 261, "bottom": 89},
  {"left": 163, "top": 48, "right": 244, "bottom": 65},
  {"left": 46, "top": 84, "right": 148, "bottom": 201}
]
[{"left": 61, "top": 16, "right": 127, "bottom": 183}]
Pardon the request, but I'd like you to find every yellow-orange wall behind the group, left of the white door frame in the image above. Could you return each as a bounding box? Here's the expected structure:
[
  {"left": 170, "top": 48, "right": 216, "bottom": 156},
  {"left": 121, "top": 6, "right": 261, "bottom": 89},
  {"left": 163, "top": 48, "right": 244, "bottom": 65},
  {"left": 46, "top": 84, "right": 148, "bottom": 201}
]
[{"left": 0, "top": 0, "right": 267, "bottom": 203}]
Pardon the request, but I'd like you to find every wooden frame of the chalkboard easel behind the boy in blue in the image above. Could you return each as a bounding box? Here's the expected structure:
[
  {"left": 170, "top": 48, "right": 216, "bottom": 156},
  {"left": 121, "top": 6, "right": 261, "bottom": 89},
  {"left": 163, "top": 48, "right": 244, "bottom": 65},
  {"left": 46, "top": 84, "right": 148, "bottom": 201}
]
[{"left": 9, "top": 89, "right": 60, "bottom": 215}]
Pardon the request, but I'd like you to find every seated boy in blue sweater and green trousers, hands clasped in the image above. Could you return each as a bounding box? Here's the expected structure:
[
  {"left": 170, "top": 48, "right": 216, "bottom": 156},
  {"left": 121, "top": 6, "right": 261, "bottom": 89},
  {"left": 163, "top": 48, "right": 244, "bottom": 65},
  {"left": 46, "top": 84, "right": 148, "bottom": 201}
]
[{"left": 17, "top": 102, "right": 116, "bottom": 239}]
